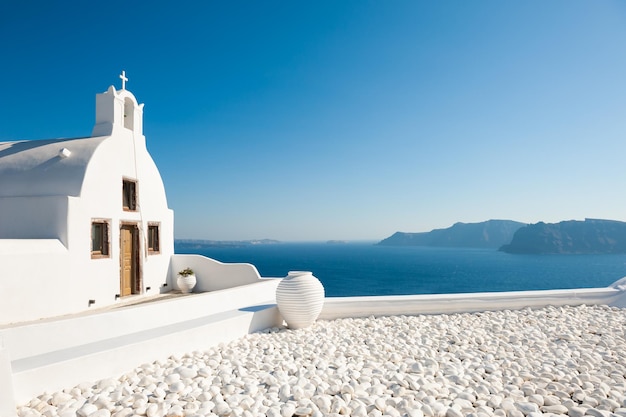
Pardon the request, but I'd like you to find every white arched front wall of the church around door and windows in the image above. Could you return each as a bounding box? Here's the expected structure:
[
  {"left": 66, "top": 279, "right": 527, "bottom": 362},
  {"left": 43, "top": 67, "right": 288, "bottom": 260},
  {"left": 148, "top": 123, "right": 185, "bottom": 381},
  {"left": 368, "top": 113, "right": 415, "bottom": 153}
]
[{"left": 71, "top": 128, "right": 174, "bottom": 306}]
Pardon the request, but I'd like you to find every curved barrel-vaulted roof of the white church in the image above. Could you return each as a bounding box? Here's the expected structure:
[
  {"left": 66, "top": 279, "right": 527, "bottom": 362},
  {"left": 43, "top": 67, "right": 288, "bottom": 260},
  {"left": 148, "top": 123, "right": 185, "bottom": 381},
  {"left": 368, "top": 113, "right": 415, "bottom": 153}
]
[{"left": 0, "top": 136, "right": 108, "bottom": 197}]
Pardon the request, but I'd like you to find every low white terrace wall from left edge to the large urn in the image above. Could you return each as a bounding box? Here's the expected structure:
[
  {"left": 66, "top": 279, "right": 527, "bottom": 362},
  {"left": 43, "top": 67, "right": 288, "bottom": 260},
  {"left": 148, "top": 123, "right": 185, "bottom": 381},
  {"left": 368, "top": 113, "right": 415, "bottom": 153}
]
[{"left": 0, "top": 276, "right": 282, "bottom": 404}]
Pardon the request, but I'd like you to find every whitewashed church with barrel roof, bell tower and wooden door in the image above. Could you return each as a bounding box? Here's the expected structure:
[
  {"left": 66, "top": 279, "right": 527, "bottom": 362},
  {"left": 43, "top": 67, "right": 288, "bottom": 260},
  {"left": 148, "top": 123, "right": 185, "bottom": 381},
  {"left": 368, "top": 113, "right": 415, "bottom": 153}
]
[{"left": 0, "top": 72, "right": 174, "bottom": 325}]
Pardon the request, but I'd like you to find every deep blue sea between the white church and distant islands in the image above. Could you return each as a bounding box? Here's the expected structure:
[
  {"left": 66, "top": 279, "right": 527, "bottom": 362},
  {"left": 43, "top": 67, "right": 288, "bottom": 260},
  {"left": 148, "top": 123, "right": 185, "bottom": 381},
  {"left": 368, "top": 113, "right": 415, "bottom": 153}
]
[{"left": 175, "top": 242, "right": 626, "bottom": 297}]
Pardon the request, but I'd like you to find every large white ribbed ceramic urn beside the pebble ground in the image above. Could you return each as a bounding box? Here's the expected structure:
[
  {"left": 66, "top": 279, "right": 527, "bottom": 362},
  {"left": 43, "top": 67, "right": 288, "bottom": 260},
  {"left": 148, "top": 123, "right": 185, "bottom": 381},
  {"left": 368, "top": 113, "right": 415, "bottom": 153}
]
[{"left": 276, "top": 271, "right": 324, "bottom": 329}]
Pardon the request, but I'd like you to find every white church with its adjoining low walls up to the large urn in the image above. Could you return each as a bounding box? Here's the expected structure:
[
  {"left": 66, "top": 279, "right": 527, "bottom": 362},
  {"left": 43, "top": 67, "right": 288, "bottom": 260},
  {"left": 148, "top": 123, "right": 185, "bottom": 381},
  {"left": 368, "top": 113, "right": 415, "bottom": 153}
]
[{"left": 0, "top": 72, "right": 283, "bottom": 406}]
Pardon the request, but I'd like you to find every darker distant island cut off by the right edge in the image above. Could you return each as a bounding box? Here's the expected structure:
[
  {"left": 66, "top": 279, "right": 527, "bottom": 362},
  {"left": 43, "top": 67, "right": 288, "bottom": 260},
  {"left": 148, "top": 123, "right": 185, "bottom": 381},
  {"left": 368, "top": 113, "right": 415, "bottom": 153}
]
[{"left": 500, "top": 219, "right": 626, "bottom": 254}]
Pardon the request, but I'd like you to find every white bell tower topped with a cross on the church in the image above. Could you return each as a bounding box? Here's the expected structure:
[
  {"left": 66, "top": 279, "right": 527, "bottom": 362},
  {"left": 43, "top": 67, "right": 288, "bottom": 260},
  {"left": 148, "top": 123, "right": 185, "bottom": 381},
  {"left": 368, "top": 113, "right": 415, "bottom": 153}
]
[{"left": 91, "top": 71, "right": 143, "bottom": 137}]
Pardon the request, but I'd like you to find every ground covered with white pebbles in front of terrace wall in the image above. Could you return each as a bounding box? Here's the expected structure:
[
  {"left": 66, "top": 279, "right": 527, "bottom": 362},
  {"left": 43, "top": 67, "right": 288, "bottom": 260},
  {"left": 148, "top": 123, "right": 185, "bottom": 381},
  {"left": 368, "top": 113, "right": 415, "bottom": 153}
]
[{"left": 18, "top": 306, "right": 626, "bottom": 417}]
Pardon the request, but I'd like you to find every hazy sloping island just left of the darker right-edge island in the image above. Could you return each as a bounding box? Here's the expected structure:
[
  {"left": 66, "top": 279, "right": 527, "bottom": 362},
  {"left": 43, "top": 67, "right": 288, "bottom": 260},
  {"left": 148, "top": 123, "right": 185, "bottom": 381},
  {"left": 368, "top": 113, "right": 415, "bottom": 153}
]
[{"left": 378, "top": 220, "right": 525, "bottom": 249}]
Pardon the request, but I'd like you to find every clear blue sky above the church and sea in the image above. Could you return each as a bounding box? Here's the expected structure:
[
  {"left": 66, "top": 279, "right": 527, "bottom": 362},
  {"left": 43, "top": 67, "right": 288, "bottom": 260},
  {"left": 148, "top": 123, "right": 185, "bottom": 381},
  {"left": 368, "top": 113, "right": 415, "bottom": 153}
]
[{"left": 0, "top": 0, "right": 626, "bottom": 241}]
